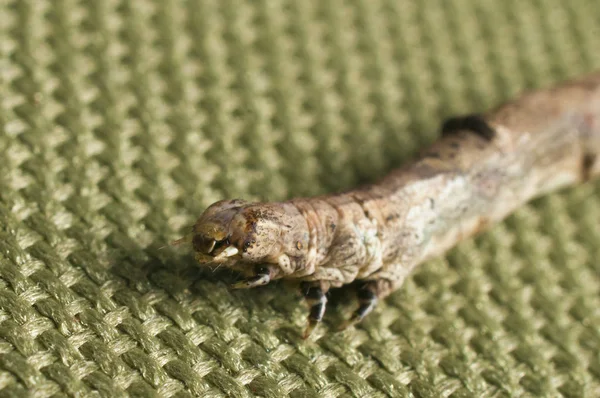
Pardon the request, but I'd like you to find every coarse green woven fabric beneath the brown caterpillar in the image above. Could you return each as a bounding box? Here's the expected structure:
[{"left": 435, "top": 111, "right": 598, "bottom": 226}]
[{"left": 0, "top": 0, "right": 600, "bottom": 398}]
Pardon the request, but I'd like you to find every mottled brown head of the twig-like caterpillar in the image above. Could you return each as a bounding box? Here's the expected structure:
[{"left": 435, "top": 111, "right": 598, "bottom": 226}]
[{"left": 185, "top": 199, "right": 308, "bottom": 279}]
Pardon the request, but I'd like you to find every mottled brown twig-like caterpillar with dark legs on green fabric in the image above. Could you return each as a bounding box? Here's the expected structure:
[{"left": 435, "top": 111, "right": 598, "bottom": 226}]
[{"left": 175, "top": 73, "right": 600, "bottom": 337}]
